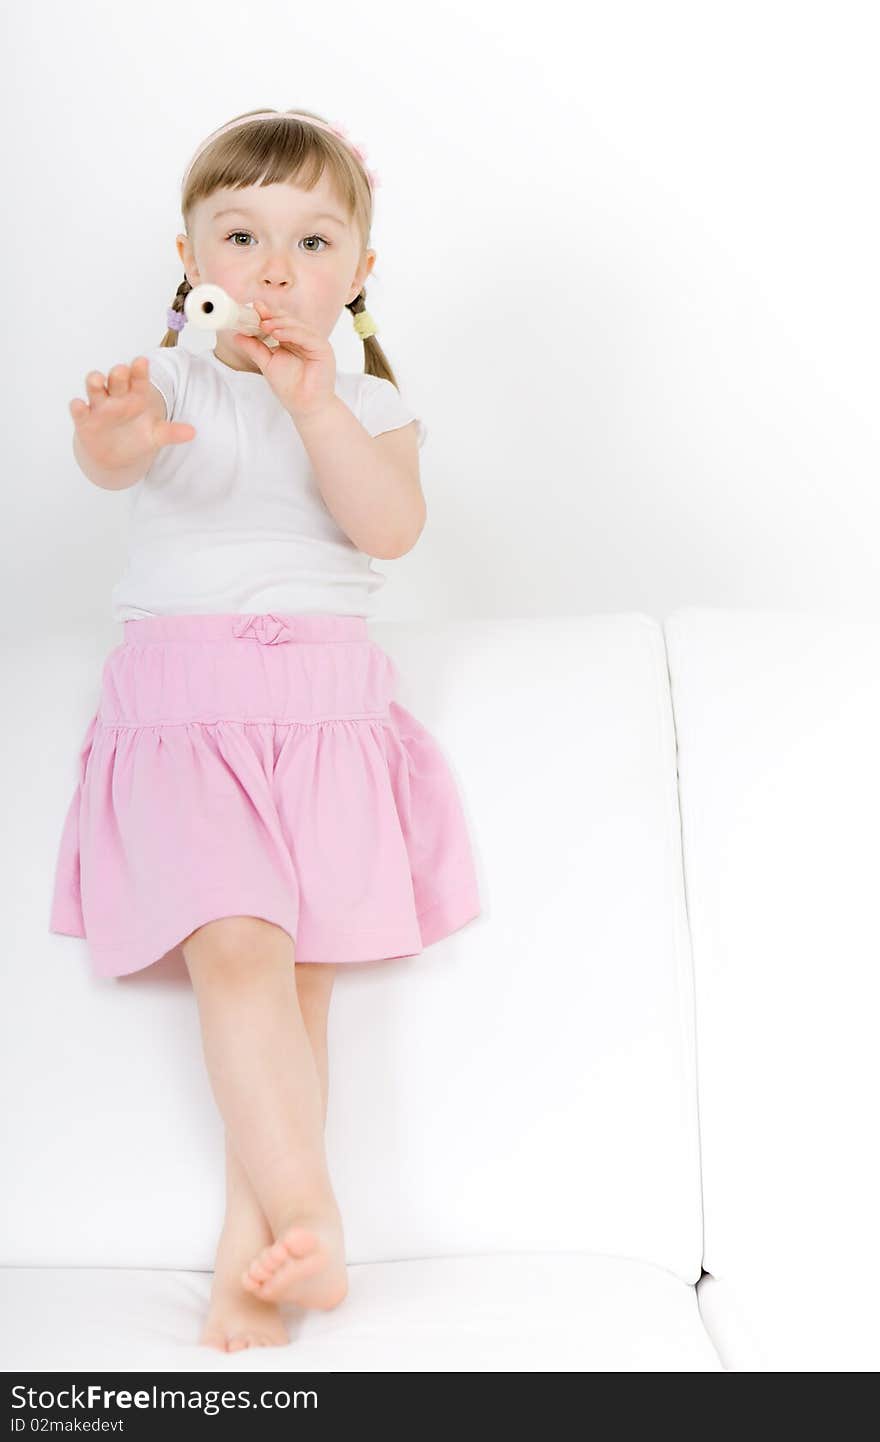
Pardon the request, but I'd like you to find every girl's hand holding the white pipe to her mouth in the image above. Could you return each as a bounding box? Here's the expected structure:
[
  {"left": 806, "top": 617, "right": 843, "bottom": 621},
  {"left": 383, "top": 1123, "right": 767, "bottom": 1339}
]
[{"left": 232, "top": 300, "right": 336, "bottom": 421}]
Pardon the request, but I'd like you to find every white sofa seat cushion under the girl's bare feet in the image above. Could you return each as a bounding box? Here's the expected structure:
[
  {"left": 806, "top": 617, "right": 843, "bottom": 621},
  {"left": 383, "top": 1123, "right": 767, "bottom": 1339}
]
[{"left": 0, "top": 1253, "right": 723, "bottom": 1371}]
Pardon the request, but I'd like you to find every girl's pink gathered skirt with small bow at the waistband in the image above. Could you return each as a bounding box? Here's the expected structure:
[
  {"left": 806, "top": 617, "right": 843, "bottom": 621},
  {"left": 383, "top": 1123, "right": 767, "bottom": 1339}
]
[{"left": 49, "top": 613, "right": 480, "bottom": 976}]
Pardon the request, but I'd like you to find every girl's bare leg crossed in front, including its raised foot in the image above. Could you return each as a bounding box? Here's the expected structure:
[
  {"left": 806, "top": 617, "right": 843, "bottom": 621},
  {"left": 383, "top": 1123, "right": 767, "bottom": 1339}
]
[{"left": 182, "top": 916, "right": 348, "bottom": 1338}]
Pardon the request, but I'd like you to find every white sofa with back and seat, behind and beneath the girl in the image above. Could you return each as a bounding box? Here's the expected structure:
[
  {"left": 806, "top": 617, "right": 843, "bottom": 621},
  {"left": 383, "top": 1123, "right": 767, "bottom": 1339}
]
[{"left": 0, "top": 609, "right": 880, "bottom": 1371}]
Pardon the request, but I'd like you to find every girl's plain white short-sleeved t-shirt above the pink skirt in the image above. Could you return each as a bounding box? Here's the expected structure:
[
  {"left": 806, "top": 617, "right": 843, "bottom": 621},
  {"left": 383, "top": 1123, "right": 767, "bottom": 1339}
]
[{"left": 111, "top": 342, "right": 427, "bottom": 622}]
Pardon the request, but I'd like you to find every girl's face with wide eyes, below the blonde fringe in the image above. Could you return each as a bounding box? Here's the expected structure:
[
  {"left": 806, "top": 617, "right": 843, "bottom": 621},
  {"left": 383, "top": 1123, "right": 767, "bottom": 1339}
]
[{"left": 177, "top": 173, "right": 375, "bottom": 371}]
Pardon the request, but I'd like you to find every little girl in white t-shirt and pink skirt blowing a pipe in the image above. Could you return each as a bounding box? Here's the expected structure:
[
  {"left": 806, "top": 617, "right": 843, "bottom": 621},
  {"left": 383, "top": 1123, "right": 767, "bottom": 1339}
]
[{"left": 49, "top": 111, "right": 480, "bottom": 1351}]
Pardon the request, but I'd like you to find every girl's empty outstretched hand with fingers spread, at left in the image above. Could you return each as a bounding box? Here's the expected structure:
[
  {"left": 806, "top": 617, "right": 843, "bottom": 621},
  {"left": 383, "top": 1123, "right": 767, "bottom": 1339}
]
[{"left": 69, "top": 356, "right": 196, "bottom": 470}]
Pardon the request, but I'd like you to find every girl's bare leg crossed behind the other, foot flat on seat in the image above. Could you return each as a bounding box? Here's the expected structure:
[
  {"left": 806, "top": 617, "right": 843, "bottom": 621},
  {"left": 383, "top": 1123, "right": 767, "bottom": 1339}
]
[{"left": 201, "top": 962, "right": 336, "bottom": 1351}]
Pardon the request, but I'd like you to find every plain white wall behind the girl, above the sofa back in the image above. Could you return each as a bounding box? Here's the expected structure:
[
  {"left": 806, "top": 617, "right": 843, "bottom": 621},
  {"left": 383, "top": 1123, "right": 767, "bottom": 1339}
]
[{"left": 1, "top": 0, "right": 880, "bottom": 640}]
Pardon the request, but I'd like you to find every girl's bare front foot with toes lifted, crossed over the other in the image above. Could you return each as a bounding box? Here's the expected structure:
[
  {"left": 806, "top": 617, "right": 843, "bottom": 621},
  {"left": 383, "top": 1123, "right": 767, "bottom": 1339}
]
[{"left": 239, "top": 1213, "right": 348, "bottom": 1311}]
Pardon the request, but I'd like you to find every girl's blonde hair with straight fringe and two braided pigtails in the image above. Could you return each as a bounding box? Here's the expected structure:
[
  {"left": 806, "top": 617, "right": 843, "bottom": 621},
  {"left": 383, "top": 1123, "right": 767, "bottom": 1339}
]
[{"left": 160, "top": 110, "right": 397, "bottom": 385}]
